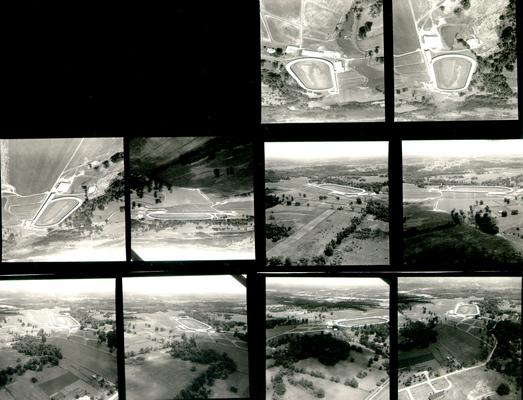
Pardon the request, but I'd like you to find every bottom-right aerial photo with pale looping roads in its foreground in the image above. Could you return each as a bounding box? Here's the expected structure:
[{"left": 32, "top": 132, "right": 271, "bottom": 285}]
[{"left": 398, "top": 276, "right": 522, "bottom": 400}]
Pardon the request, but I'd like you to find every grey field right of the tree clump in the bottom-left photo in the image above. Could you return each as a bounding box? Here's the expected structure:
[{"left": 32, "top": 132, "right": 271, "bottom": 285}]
[{"left": 47, "top": 337, "right": 117, "bottom": 382}]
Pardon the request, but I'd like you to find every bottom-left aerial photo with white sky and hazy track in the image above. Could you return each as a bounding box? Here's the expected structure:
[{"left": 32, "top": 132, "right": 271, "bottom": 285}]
[{"left": 0, "top": 279, "right": 118, "bottom": 400}]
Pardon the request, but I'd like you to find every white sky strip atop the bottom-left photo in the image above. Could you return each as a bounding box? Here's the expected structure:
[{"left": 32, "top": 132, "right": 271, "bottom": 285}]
[{"left": 0, "top": 279, "right": 115, "bottom": 295}]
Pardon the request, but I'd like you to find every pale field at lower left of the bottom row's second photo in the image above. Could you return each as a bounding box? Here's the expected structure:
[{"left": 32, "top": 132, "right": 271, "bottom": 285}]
[{"left": 125, "top": 352, "right": 207, "bottom": 400}]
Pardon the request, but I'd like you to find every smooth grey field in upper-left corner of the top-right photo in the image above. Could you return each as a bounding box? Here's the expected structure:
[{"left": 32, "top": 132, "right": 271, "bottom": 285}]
[{"left": 392, "top": 0, "right": 420, "bottom": 55}]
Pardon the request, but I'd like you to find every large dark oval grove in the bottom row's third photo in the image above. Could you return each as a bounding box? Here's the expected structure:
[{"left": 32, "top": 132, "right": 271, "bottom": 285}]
[{"left": 269, "top": 333, "right": 350, "bottom": 366}]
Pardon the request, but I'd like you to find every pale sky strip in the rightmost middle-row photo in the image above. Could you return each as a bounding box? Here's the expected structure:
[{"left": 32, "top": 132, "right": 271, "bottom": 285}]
[{"left": 403, "top": 139, "right": 523, "bottom": 157}]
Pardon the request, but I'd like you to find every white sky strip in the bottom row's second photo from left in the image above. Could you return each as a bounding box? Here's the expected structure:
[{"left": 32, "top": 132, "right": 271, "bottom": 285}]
[{"left": 123, "top": 275, "right": 247, "bottom": 295}]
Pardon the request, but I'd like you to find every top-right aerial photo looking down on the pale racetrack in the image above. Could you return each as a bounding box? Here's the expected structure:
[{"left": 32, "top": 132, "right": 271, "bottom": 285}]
[{"left": 392, "top": 0, "right": 518, "bottom": 121}]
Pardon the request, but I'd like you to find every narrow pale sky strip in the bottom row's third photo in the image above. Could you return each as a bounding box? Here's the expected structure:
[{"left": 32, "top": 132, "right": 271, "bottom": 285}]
[{"left": 266, "top": 276, "right": 389, "bottom": 290}]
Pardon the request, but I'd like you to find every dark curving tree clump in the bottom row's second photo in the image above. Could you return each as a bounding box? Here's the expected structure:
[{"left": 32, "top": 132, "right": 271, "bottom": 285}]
[{"left": 169, "top": 334, "right": 238, "bottom": 399}]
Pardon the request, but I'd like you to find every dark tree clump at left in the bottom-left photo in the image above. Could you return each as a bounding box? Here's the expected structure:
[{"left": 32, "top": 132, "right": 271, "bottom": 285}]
[{"left": 0, "top": 334, "right": 62, "bottom": 387}]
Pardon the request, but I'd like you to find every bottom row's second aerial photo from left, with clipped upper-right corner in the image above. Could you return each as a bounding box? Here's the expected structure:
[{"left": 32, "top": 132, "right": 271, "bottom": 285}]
[{"left": 123, "top": 275, "right": 249, "bottom": 400}]
